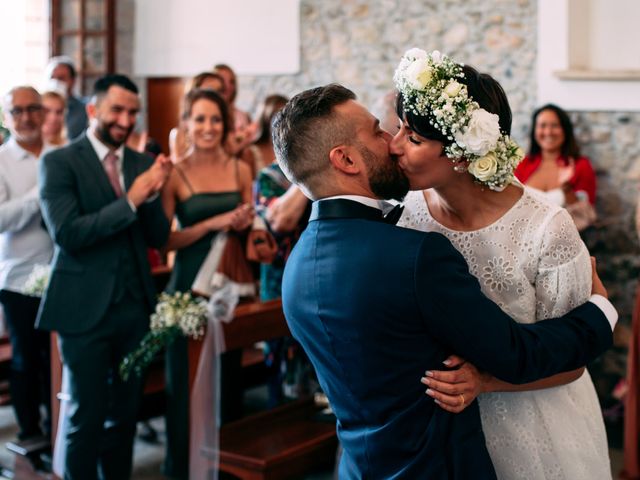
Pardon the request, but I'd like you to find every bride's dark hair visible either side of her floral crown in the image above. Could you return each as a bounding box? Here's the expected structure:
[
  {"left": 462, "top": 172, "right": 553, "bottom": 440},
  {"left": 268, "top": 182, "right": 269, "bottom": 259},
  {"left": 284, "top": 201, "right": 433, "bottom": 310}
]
[{"left": 396, "top": 65, "right": 512, "bottom": 147}]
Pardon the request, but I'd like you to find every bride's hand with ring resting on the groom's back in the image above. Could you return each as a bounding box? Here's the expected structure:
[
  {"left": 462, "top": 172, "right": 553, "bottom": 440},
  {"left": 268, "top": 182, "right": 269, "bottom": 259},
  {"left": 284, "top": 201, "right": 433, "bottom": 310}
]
[{"left": 420, "top": 355, "right": 492, "bottom": 413}]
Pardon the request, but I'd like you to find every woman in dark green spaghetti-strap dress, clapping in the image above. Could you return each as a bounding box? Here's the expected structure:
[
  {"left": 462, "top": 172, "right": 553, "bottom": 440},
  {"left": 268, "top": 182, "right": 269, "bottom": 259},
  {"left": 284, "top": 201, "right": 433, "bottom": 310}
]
[{"left": 162, "top": 89, "right": 253, "bottom": 479}]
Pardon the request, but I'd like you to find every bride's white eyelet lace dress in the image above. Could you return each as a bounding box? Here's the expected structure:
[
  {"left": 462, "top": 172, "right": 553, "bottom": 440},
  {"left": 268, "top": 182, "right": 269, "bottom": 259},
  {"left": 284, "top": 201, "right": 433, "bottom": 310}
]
[{"left": 398, "top": 189, "right": 611, "bottom": 480}]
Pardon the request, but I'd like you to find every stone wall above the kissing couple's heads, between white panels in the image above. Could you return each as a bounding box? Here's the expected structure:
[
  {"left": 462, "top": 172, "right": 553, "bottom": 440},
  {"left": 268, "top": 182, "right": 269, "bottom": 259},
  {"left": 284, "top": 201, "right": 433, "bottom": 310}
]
[{"left": 238, "top": 0, "right": 536, "bottom": 144}]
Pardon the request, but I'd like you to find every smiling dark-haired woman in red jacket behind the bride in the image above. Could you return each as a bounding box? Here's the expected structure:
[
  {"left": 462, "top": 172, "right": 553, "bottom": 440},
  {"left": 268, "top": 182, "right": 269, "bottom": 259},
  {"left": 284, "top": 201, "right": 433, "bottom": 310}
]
[{"left": 515, "top": 104, "right": 596, "bottom": 230}]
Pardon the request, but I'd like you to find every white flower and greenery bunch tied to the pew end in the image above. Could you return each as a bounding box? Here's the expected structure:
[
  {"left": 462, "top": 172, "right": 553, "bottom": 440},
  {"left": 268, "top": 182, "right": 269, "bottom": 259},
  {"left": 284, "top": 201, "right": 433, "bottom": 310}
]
[{"left": 119, "top": 292, "right": 207, "bottom": 381}]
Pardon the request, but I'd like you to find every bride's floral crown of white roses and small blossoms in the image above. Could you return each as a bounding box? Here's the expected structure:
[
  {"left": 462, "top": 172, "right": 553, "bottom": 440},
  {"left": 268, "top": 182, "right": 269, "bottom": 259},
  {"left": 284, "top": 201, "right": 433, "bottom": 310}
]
[{"left": 393, "top": 48, "right": 524, "bottom": 191}]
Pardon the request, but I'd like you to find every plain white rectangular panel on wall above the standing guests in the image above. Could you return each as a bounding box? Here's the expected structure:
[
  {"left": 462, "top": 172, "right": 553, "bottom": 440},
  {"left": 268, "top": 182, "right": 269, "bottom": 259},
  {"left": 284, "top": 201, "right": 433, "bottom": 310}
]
[{"left": 134, "top": 0, "right": 300, "bottom": 77}]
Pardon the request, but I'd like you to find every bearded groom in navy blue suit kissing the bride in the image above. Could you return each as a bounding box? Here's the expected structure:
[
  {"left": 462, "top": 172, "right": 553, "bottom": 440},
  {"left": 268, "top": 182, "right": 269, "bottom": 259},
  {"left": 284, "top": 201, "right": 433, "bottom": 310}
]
[{"left": 273, "top": 85, "right": 617, "bottom": 480}]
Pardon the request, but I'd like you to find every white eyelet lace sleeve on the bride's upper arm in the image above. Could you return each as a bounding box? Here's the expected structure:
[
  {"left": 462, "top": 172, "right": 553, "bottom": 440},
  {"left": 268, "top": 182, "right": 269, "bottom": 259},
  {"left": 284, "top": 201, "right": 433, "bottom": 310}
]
[{"left": 535, "top": 209, "right": 591, "bottom": 320}]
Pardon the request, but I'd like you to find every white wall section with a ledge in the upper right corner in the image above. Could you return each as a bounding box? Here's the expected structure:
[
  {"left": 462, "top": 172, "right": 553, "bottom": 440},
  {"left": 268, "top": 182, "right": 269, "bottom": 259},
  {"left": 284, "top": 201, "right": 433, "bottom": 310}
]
[{"left": 537, "top": 0, "right": 640, "bottom": 111}]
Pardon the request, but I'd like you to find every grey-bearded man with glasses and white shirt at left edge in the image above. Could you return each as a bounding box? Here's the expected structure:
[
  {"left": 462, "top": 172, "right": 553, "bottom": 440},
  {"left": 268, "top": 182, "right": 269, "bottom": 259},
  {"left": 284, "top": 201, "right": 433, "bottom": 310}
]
[{"left": 0, "top": 87, "right": 53, "bottom": 439}]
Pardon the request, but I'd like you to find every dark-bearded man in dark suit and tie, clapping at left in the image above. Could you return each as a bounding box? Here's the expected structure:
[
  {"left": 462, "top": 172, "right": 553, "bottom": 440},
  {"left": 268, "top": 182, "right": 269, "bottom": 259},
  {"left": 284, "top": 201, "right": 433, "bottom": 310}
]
[{"left": 38, "top": 75, "right": 171, "bottom": 480}]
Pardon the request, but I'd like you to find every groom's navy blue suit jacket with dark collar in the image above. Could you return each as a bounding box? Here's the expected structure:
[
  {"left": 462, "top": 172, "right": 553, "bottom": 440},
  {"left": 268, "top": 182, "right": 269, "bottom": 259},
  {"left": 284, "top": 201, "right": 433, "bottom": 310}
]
[{"left": 282, "top": 200, "right": 612, "bottom": 480}]
